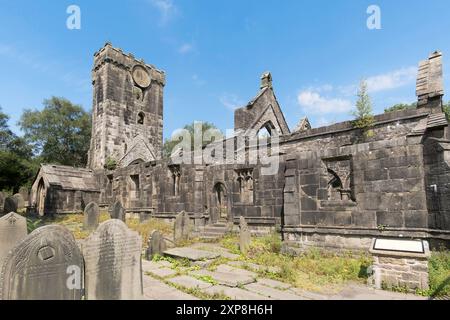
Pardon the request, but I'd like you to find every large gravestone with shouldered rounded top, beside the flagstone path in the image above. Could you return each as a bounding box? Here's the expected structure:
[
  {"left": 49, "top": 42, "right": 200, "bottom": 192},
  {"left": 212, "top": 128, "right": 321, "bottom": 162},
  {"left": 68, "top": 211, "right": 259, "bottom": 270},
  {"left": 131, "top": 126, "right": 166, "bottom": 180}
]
[{"left": 83, "top": 219, "right": 143, "bottom": 300}]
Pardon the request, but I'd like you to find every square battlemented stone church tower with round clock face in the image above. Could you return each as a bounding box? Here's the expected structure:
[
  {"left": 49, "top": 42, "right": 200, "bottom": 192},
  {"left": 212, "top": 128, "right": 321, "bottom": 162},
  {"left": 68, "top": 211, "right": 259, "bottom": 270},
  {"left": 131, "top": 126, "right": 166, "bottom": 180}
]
[{"left": 88, "top": 43, "right": 165, "bottom": 170}]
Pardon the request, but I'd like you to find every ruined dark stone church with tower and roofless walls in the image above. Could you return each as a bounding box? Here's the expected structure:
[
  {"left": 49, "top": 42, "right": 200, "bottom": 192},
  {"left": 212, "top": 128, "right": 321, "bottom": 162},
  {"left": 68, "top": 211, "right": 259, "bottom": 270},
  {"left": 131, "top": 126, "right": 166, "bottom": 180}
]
[{"left": 31, "top": 43, "right": 450, "bottom": 250}]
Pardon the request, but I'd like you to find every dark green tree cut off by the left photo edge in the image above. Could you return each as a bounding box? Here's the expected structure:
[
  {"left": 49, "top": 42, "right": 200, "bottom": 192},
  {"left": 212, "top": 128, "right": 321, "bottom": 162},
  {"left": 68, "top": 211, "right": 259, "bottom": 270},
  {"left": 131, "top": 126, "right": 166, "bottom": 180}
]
[{"left": 0, "top": 108, "right": 38, "bottom": 193}]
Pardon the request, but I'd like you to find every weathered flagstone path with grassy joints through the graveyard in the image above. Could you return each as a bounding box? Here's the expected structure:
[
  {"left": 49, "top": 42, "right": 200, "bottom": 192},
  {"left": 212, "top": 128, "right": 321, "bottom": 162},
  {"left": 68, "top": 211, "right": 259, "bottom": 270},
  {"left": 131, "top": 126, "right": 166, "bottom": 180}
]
[{"left": 142, "top": 243, "right": 427, "bottom": 300}]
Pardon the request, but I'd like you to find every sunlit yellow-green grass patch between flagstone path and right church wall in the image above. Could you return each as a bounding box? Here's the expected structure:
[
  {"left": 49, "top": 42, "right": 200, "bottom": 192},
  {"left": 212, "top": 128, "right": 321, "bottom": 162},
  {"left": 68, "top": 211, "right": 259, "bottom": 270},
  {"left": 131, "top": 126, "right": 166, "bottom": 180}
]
[{"left": 221, "top": 233, "right": 372, "bottom": 291}]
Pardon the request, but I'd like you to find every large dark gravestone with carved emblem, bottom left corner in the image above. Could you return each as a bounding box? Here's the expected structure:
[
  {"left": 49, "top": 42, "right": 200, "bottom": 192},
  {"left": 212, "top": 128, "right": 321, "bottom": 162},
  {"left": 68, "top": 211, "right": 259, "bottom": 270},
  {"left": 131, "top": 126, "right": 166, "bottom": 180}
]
[{"left": 0, "top": 225, "right": 83, "bottom": 300}]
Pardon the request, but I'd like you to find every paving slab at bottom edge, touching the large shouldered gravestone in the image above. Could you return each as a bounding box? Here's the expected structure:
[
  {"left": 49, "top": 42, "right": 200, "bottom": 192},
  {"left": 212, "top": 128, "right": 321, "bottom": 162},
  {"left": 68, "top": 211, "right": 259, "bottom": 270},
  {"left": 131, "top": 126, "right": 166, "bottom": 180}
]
[{"left": 143, "top": 275, "right": 198, "bottom": 300}]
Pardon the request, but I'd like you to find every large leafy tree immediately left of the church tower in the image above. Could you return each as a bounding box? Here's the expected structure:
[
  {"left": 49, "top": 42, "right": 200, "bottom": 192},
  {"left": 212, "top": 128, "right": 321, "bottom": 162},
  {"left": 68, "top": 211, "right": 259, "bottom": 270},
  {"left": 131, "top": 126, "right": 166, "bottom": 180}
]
[{"left": 19, "top": 97, "right": 91, "bottom": 167}]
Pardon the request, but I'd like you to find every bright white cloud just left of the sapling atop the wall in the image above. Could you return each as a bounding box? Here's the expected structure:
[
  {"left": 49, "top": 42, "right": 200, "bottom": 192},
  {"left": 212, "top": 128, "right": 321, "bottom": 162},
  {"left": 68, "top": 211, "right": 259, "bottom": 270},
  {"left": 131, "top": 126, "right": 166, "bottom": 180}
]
[{"left": 297, "top": 89, "right": 353, "bottom": 114}]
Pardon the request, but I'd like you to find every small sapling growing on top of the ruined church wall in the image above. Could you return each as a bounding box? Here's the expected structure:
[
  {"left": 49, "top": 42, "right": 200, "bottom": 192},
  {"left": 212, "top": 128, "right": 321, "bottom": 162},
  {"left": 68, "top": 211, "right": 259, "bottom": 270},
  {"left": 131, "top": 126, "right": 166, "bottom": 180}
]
[{"left": 352, "top": 80, "right": 375, "bottom": 136}]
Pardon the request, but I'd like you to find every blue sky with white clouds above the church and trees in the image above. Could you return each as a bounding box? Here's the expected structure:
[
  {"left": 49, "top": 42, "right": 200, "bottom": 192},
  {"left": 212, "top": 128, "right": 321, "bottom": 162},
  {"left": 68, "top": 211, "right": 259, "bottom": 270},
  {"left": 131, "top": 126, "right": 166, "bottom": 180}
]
[{"left": 0, "top": 0, "right": 450, "bottom": 138}]
